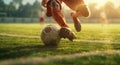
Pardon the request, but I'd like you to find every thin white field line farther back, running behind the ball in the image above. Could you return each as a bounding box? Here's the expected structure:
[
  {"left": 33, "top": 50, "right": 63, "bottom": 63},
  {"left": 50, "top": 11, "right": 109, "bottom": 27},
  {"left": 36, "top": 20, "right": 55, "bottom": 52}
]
[{"left": 0, "top": 33, "right": 120, "bottom": 44}]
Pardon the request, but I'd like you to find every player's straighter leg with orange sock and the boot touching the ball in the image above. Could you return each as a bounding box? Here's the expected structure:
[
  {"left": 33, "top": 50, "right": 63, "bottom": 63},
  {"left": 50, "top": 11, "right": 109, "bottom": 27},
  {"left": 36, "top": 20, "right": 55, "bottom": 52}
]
[{"left": 51, "top": 1, "right": 76, "bottom": 41}]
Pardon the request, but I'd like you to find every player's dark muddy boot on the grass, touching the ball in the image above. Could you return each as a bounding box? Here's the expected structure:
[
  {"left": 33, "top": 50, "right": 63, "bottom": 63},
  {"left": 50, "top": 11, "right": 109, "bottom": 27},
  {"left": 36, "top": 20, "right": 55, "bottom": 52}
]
[{"left": 59, "top": 27, "right": 76, "bottom": 41}]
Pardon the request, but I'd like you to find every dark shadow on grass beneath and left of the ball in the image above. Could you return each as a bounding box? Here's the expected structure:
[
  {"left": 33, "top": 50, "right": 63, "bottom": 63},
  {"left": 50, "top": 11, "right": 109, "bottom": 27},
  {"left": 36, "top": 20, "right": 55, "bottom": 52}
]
[{"left": 0, "top": 45, "right": 57, "bottom": 60}]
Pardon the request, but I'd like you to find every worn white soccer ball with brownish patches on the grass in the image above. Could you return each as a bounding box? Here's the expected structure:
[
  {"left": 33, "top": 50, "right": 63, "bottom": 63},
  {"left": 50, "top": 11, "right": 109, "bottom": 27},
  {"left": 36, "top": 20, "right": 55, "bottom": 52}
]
[{"left": 41, "top": 25, "right": 61, "bottom": 46}]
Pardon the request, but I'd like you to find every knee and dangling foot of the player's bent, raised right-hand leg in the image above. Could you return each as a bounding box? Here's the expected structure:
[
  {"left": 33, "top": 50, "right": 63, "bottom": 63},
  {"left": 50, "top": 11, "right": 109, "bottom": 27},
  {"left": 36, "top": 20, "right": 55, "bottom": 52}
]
[{"left": 72, "top": 4, "right": 89, "bottom": 32}]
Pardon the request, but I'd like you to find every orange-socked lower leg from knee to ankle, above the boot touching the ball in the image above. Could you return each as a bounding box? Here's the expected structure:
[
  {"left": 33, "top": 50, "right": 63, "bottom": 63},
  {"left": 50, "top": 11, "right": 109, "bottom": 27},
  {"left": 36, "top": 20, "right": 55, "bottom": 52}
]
[{"left": 51, "top": 1, "right": 68, "bottom": 27}]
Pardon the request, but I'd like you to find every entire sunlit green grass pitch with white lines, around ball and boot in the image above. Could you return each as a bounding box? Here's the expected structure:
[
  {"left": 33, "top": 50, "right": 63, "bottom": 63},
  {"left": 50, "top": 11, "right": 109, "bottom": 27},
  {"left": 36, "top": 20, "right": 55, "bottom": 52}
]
[{"left": 0, "top": 24, "right": 120, "bottom": 65}]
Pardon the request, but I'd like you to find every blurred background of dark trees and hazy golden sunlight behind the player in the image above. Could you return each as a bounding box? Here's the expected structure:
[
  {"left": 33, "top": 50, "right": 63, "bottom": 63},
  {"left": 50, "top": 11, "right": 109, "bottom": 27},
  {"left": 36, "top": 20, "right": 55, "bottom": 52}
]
[{"left": 0, "top": 0, "right": 120, "bottom": 23}]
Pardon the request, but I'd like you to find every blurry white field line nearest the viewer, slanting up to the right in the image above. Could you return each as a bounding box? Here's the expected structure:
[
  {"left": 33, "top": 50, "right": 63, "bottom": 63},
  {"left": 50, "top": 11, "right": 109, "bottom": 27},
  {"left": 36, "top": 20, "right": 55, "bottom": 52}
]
[{"left": 0, "top": 50, "right": 120, "bottom": 65}]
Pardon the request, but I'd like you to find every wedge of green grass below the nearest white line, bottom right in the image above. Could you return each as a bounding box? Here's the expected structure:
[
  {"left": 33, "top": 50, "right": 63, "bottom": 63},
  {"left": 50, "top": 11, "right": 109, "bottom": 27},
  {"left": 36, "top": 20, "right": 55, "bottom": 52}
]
[{"left": 42, "top": 54, "right": 120, "bottom": 65}]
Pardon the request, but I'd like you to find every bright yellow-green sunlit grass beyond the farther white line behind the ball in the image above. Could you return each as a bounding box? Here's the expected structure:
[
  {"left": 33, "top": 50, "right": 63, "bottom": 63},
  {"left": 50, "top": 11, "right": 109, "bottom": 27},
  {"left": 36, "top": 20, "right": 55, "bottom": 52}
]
[{"left": 0, "top": 24, "right": 120, "bottom": 42}]
